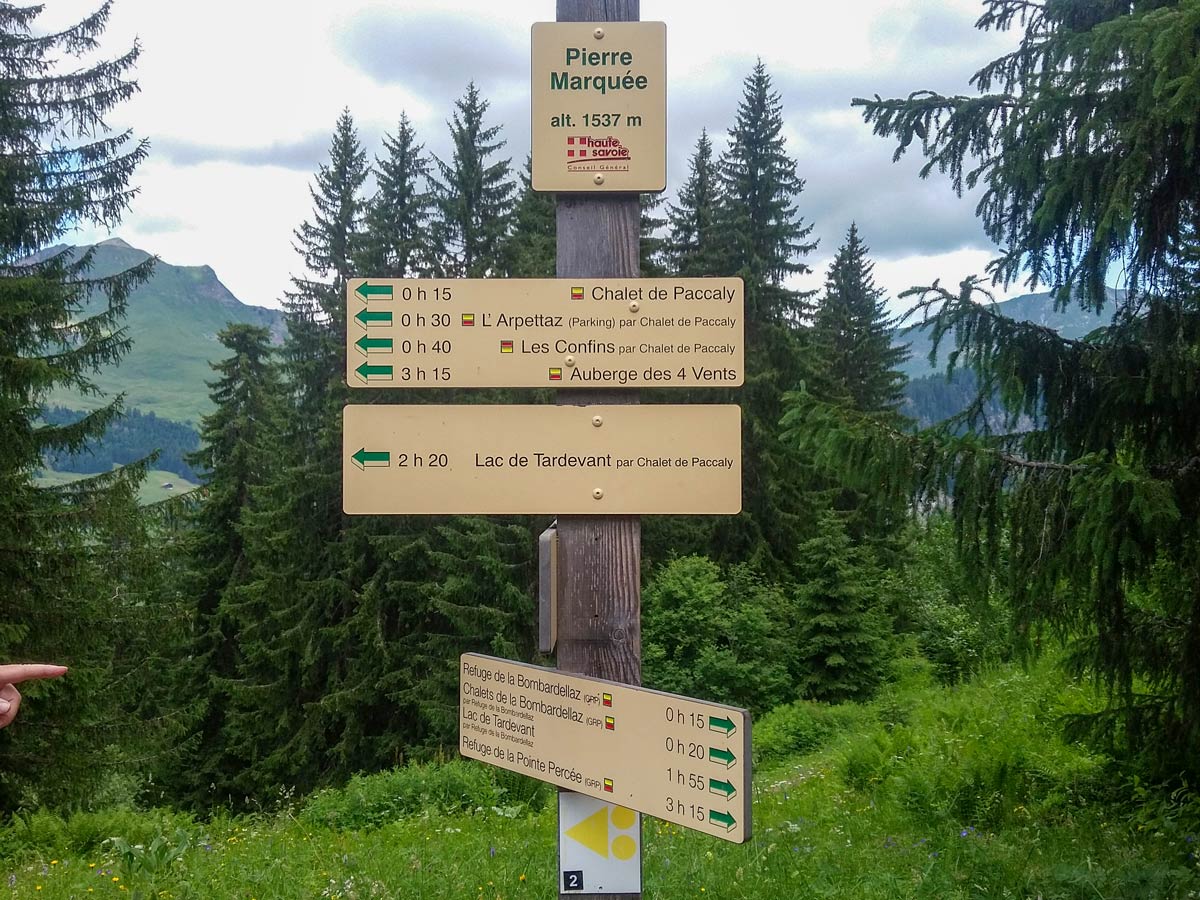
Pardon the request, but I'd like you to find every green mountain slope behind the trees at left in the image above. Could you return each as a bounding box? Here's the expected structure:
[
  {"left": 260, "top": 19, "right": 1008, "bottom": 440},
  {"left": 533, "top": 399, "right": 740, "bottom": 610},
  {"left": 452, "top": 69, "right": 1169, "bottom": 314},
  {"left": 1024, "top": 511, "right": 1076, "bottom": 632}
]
[{"left": 46, "top": 238, "right": 283, "bottom": 425}]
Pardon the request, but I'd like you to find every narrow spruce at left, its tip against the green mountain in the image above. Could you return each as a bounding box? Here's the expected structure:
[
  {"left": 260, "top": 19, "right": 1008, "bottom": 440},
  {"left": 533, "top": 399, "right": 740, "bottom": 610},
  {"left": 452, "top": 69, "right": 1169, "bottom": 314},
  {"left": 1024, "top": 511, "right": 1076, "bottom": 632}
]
[{"left": 181, "top": 324, "right": 282, "bottom": 804}]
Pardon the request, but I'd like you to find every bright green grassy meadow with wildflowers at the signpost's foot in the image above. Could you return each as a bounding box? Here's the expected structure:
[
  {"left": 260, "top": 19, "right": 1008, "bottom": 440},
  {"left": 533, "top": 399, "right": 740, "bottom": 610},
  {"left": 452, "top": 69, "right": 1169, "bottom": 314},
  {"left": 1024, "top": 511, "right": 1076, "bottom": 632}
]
[{"left": 0, "top": 664, "right": 1200, "bottom": 900}]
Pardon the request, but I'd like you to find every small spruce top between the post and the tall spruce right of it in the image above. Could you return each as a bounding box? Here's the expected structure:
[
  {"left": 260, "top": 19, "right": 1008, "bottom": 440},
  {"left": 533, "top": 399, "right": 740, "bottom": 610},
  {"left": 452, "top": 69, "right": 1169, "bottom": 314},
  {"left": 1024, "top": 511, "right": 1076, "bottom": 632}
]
[{"left": 664, "top": 130, "right": 721, "bottom": 278}]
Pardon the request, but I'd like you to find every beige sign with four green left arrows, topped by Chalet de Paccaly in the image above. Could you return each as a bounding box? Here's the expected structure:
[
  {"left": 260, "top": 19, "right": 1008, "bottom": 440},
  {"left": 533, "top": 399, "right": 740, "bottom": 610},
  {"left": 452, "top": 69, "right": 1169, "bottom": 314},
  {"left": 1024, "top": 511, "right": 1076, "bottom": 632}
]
[{"left": 346, "top": 278, "right": 745, "bottom": 388}]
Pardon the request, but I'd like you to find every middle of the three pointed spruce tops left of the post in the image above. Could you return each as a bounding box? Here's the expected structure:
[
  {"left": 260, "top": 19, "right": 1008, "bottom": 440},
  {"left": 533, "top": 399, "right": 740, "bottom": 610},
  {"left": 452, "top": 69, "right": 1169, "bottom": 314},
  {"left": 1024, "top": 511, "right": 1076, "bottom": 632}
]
[{"left": 356, "top": 115, "right": 433, "bottom": 278}]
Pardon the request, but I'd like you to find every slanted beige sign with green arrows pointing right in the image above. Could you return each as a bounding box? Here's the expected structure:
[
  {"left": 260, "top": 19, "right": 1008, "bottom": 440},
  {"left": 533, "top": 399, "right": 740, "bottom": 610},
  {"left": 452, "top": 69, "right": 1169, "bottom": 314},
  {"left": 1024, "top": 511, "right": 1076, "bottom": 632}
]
[{"left": 458, "top": 653, "right": 750, "bottom": 844}]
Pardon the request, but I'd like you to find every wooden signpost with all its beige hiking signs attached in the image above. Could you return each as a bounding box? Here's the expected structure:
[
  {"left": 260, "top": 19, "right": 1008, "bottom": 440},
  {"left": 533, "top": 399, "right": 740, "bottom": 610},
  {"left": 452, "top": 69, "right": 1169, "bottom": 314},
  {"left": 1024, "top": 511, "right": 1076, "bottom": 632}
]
[{"left": 343, "top": 0, "right": 751, "bottom": 900}]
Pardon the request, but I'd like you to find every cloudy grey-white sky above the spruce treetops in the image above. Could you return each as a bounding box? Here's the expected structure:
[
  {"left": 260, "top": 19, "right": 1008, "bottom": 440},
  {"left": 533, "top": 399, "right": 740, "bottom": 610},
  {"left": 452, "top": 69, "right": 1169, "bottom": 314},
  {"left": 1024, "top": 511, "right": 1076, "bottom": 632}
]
[{"left": 49, "top": 0, "right": 1020, "bottom": 314}]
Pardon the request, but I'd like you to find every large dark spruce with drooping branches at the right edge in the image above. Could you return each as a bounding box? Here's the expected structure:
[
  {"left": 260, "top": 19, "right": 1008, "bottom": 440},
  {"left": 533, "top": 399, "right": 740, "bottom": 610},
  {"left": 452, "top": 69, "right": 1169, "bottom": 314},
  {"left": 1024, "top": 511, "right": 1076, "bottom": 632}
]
[{"left": 793, "top": 0, "right": 1200, "bottom": 778}]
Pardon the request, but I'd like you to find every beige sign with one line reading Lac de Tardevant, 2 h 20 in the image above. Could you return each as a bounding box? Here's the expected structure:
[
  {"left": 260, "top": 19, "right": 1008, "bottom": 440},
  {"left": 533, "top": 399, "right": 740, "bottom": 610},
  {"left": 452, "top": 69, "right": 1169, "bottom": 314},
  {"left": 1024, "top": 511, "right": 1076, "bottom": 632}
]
[{"left": 342, "top": 404, "right": 742, "bottom": 515}]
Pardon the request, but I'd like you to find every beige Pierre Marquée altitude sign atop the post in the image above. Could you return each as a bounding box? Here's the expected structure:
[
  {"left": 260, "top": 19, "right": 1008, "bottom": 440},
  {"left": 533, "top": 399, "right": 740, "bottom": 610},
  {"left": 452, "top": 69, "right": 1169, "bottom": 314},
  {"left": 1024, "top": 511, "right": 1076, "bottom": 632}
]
[{"left": 532, "top": 22, "right": 667, "bottom": 192}]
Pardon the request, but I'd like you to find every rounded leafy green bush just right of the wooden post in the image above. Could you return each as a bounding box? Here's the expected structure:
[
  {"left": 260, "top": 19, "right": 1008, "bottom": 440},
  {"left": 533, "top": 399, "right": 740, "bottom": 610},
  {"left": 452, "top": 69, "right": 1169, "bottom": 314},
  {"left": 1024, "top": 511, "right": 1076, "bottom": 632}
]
[{"left": 642, "top": 557, "right": 796, "bottom": 710}]
